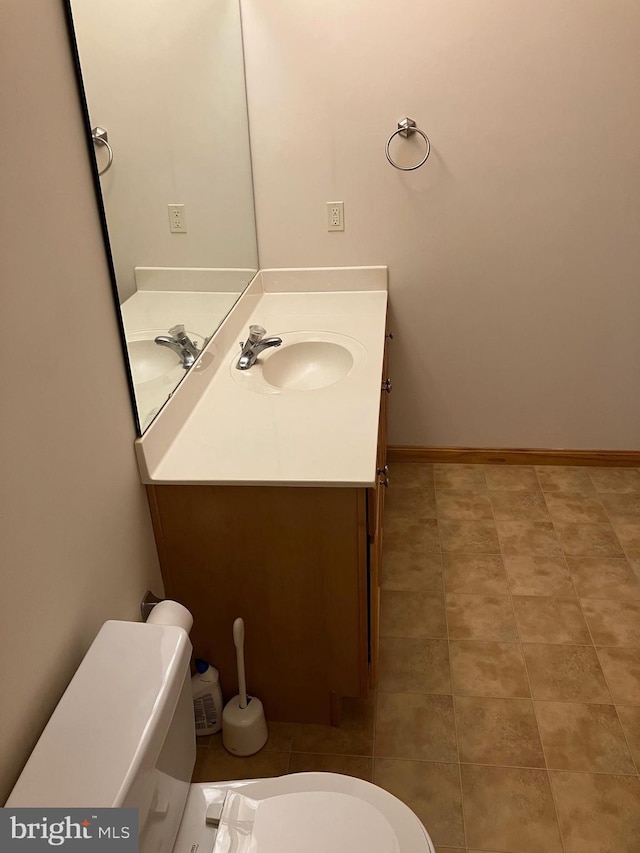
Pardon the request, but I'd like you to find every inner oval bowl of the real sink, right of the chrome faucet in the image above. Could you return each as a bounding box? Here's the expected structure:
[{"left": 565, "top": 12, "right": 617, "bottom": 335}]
[{"left": 262, "top": 341, "right": 353, "bottom": 391}]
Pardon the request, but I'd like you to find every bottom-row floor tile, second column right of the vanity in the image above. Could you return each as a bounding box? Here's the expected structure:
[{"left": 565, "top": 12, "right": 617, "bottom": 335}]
[{"left": 461, "top": 764, "right": 562, "bottom": 853}]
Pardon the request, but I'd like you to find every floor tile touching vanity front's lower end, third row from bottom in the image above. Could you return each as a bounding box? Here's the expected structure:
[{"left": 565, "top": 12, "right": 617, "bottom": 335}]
[{"left": 378, "top": 637, "right": 452, "bottom": 694}]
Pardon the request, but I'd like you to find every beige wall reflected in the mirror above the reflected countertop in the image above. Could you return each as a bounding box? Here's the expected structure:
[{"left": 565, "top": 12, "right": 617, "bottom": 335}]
[{"left": 72, "top": 0, "right": 257, "bottom": 301}]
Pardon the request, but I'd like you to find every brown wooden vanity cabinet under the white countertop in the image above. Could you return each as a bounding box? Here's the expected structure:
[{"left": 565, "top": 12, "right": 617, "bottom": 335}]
[{"left": 147, "top": 336, "right": 388, "bottom": 724}]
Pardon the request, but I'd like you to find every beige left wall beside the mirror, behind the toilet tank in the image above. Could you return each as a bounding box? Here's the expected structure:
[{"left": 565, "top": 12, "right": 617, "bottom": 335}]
[{"left": 0, "top": 0, "right": 161, "bottom": 803}]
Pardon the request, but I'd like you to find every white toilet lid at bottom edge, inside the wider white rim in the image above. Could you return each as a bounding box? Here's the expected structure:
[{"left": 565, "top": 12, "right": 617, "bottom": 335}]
[{"left": 213, "top": 790, "right": 400, "bottom": 853}]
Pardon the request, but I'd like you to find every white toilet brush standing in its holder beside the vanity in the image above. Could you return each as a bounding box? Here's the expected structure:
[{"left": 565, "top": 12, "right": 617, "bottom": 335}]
[{"left": 222, "top": 618, "right": 268, "bottom": 755}]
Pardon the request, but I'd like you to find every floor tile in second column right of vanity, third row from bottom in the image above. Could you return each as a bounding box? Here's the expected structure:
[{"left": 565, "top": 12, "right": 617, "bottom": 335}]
[{"left": 450, "top": 640, "right": 531, "bottom": 698}]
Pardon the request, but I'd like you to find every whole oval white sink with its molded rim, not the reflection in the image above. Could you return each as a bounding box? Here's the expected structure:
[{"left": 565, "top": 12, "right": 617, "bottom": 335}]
[{"left": 231, "top": 331, "right": 366, "bottom": 394}]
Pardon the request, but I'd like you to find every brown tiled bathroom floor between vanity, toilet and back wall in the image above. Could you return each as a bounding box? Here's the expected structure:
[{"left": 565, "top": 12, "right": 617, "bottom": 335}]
[{"left": 194, "top": 464, "right": 640, "bottom": 853}]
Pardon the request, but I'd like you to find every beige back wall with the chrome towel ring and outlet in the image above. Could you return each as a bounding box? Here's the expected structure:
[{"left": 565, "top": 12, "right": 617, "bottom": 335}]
[{"left": 242, "top": 0, "right": 640, "bottom": 449}]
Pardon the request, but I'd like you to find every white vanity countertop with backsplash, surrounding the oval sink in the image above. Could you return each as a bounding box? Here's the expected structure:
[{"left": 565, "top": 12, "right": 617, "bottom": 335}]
[{"left": 136, "top": 267, "right": 387, "bottom": 487}]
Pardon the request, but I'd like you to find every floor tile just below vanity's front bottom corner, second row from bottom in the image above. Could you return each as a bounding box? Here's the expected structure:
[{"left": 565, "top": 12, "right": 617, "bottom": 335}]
[{"left": 374, "top": 693, "right": 458, "bottom": 761}]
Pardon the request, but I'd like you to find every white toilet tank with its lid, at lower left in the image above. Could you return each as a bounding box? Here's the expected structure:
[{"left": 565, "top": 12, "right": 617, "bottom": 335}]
[{"left": 6, "top": 621, "right": 195, "bottom": 853}]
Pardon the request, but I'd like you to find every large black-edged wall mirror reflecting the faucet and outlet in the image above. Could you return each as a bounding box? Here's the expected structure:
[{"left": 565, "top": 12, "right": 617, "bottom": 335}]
[{"left": 63, "top": 0, "right": 258, "bottom": 433}]
